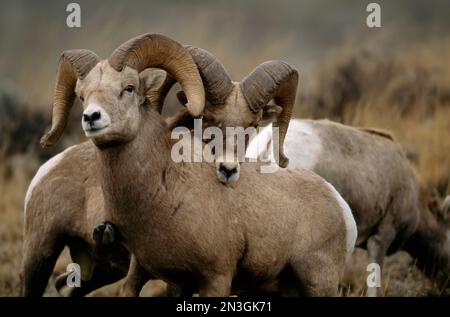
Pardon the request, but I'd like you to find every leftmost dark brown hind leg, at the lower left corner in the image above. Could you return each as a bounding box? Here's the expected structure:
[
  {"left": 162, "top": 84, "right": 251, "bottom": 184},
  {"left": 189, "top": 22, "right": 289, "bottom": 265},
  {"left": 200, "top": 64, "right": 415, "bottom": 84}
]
[{"left": 20, "top": 232, "right": 64, "bottom": 296}]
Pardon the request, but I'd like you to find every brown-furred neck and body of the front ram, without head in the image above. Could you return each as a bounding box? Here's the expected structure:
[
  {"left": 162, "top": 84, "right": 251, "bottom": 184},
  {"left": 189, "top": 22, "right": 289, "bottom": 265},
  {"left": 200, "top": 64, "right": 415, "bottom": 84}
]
[{"left": 97, "top": 110, "right": 354, "bottom": 296}]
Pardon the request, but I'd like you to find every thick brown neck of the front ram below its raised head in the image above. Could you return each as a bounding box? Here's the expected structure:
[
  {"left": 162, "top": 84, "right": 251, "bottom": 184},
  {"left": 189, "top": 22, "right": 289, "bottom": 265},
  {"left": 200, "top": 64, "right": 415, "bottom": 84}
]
[{"left": 98, "top": 112, "right": 174, "bottom": 232}]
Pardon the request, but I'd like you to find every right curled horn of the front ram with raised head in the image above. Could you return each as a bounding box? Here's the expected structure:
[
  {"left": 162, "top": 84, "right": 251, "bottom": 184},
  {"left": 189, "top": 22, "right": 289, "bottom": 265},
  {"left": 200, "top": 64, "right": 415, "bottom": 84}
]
[{"left": 108, "top": 34, "right": 205, "bottom": 117}]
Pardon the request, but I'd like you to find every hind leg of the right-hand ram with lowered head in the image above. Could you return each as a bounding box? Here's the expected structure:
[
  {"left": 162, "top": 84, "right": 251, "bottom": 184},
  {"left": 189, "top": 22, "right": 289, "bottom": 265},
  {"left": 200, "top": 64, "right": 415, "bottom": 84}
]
[{"left": 367, "top": 214, "right": 396, "bottom": 297}]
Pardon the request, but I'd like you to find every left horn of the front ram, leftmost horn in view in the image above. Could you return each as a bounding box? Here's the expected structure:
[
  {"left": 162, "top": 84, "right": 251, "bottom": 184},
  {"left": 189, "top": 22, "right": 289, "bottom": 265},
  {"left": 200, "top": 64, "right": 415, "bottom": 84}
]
[{"left": 41, "top": 50, "right": 100, "bottom": 147}]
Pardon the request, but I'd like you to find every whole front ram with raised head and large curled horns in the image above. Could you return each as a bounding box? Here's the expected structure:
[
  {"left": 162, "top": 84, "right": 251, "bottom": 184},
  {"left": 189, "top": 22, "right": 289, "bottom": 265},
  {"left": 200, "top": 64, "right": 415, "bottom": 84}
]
[{"left": 37, "top": 34, "right": 356, "bottom": 296}]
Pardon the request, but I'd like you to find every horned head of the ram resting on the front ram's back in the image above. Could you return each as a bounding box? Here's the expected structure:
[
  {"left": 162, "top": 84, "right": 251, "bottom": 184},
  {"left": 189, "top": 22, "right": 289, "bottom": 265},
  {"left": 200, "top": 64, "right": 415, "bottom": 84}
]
[{"left": 178, "top": 46, "right": 298, "bottom": 183}]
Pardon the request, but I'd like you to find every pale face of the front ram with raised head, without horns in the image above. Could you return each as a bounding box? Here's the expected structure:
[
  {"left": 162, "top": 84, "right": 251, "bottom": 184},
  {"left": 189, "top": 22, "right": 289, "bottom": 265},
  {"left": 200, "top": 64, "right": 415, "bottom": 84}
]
[{"left": 75, "top": 61, "right": 144, "bottom": 143}]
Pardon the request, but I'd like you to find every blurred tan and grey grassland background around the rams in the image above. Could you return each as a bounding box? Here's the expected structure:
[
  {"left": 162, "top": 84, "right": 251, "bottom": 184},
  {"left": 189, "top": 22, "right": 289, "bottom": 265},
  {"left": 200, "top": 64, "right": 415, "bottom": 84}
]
[{"left": 0, "top": 0, "right": 450, "bottom": 296}]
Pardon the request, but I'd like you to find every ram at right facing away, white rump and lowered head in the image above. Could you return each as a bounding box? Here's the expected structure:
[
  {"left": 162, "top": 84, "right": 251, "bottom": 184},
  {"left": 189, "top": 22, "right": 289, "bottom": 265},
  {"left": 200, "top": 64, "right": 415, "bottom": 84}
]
[{"left": 247, "top": 119, "right": 450, "bottom": 295}]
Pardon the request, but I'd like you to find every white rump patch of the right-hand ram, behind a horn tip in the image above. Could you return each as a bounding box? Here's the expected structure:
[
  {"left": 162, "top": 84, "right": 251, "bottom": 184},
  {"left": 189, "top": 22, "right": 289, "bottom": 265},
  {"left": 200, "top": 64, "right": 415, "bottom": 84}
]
[{"left": 246, "top": 119, "right": 322, "bottom": 170}]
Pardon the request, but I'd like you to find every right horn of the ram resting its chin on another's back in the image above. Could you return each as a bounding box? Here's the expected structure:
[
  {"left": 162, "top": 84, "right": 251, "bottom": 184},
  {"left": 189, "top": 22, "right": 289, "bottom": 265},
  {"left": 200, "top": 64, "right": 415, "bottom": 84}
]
[{"left": 240, "top": 61, "right": 298, "bottom": 167}]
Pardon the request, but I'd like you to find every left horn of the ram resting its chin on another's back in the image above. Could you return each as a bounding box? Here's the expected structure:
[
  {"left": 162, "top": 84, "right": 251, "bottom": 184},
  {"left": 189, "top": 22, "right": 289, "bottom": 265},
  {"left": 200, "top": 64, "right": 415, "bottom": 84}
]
[{"left": 184, "top": 45, "right": 234, "bottom": 105}]
